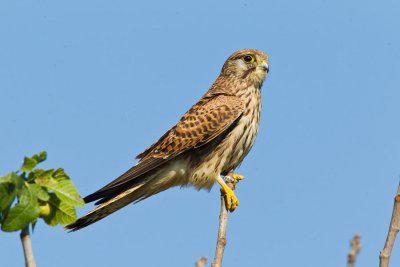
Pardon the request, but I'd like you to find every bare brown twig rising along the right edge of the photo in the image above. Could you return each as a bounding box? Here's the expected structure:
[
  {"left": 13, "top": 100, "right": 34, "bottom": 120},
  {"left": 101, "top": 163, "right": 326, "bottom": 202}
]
[{"left": 379, "top": 185, "right": 400, "bottom": 267}]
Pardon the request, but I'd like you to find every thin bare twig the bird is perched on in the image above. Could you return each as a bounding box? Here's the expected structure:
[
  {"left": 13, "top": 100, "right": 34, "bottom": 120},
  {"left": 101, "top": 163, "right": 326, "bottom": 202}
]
[{"left": 211, "top": 171, "right": 235, "bottom": 267}]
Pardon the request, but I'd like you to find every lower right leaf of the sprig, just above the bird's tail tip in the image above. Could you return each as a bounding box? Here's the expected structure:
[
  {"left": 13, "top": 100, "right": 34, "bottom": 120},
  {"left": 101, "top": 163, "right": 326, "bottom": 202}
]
[{"left": 43, "top": 193, "right": 76, "bottom": 226}]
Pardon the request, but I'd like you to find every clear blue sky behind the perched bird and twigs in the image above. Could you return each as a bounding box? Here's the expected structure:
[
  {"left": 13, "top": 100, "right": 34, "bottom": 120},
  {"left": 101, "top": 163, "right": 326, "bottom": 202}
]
[{"left": 0, "top": 0, "right": 400, "bottom": 267}]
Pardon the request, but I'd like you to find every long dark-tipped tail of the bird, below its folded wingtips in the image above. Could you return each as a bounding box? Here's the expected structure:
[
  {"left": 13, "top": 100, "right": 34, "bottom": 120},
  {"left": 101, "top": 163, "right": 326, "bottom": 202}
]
[{"left": 65, "top": 172, "right": 178, "bottom": 232}]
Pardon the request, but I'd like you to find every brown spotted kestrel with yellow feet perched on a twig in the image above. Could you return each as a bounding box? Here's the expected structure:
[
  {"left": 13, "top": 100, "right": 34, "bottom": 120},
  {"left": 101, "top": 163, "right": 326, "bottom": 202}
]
[{"left": 66, "top": 49, "right": 269, "bottom": 231}]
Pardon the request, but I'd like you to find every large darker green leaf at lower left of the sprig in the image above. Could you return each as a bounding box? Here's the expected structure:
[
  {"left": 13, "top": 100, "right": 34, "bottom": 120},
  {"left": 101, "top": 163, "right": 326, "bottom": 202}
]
[{"left": 1, "top": 186, "right": 40, "bottom": 232}]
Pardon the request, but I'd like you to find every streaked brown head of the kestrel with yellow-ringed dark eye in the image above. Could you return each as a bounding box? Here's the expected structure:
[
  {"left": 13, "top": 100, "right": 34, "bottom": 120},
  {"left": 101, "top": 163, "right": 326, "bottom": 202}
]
[{"left": 221, "top": 49, "right": 269, "bottom": 86}]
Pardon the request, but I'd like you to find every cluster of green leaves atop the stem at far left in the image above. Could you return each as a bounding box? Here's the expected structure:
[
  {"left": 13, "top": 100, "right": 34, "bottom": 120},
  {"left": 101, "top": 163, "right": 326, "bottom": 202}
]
[{"left": 0, "top": 151, "right": 85, "bottom": 232}]
